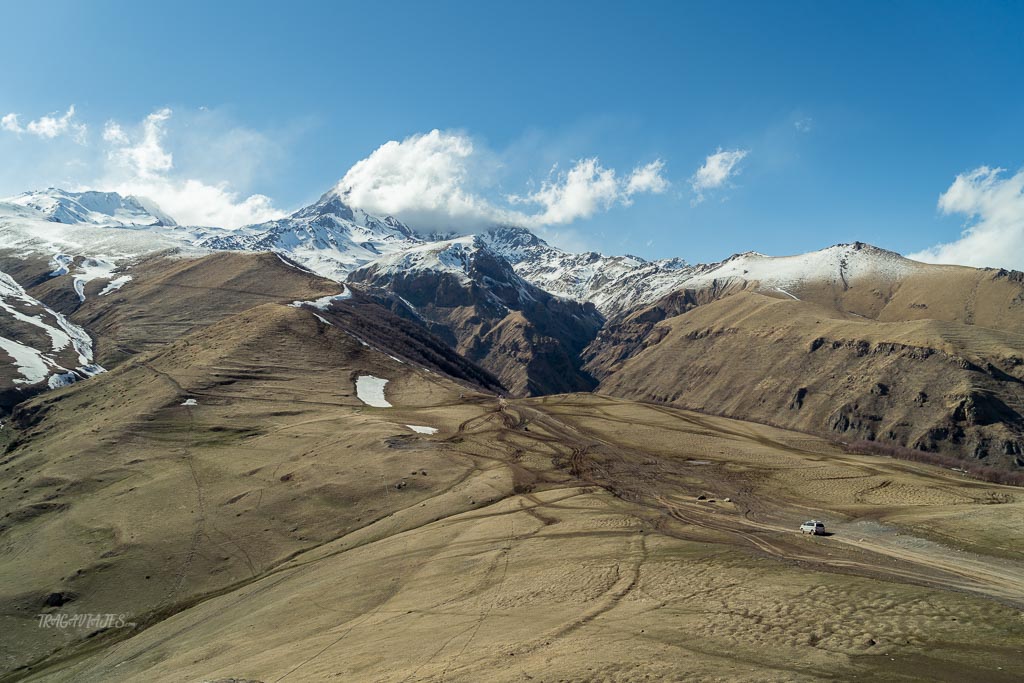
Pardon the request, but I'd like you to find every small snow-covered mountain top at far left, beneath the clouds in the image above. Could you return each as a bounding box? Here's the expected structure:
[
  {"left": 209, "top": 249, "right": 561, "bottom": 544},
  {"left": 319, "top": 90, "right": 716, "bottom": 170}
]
[{"left": 2, "top": 187, "right": 177, "bottom": 226}]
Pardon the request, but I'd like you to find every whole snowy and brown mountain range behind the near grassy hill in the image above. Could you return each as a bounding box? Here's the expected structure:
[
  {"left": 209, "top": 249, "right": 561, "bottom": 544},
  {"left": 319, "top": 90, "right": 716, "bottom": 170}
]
[{"left": 6, "top": 181, "right": 1024, "bottom": 468}]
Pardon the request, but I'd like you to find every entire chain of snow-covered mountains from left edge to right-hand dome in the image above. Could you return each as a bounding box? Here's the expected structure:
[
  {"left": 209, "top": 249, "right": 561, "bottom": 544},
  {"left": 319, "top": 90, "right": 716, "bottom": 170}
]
[{"left": 0, "top": 188, "right": 937, "bottom": 316}]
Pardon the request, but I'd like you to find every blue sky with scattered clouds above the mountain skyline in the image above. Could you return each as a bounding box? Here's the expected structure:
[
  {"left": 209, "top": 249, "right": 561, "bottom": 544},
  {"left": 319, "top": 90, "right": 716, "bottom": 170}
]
[{"left": 0, "top": 0, "right": 1024, "bottom": 267}]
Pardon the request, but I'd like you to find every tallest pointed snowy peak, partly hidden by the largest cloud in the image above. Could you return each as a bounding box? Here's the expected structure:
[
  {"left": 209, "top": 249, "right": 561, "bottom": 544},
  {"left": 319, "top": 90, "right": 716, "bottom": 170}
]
[{"left": 198, "top": 189, "right": 423, "bottom": 281}]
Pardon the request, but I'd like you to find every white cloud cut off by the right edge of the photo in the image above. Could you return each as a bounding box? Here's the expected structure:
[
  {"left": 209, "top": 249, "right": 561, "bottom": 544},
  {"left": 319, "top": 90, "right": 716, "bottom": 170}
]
[{"left": 909, "top": 166, "right": 1024, "bottom": 269}]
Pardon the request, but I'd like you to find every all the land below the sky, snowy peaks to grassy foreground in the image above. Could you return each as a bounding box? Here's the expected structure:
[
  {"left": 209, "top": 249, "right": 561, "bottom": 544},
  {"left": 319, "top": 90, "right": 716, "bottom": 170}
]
[{"left": 0, "top": 188, "right": 1024, "bottom": 683}]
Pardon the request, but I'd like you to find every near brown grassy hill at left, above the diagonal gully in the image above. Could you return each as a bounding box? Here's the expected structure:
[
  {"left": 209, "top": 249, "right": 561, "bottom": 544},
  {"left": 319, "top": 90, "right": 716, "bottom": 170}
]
[{"left": 0, "top": 304, "right": 495, "bottom": 668}]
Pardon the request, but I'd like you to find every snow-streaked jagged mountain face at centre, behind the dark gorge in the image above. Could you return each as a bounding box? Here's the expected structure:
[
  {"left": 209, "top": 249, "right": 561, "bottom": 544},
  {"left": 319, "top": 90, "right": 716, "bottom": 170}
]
[{"left": 481, "top": 226, "right": 696, "bottom": 315}]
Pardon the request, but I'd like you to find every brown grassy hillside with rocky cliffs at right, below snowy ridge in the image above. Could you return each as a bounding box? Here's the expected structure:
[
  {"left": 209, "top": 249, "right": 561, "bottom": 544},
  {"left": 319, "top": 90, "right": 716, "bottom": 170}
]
[{"left": 585, "top": 265, "right": 1024, "bottom": 468}]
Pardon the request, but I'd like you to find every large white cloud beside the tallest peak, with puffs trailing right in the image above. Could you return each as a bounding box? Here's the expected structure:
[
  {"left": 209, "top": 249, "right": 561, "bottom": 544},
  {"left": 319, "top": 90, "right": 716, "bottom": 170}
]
[{"left": 337, "top": 130, "right": 669, "bottom": 230}]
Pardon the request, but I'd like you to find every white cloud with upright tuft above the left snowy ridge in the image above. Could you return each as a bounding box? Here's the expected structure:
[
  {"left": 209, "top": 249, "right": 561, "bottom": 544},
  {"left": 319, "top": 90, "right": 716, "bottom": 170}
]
[{"left": 96, "top": 109, "right": 285, "bottom": 227}]
